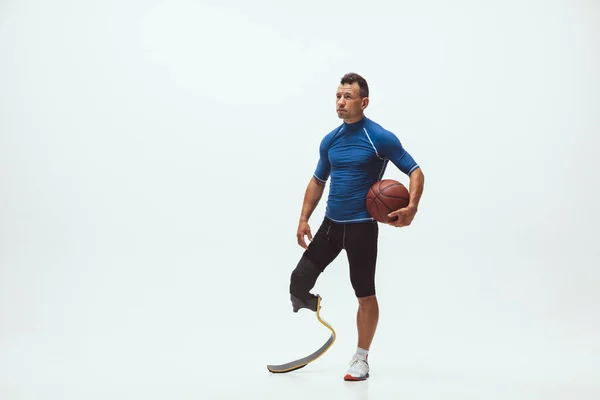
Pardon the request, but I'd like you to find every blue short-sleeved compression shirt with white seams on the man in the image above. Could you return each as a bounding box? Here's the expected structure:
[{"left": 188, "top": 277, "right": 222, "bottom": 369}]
[{"left": 314, "top": 117, "right": 419, "bottom": 223}]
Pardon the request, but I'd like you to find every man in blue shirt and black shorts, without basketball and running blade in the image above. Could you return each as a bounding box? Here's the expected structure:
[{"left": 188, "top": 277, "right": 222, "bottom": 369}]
[{"left": 290, "top": 73, "right": 424, "bottom": 381}]
